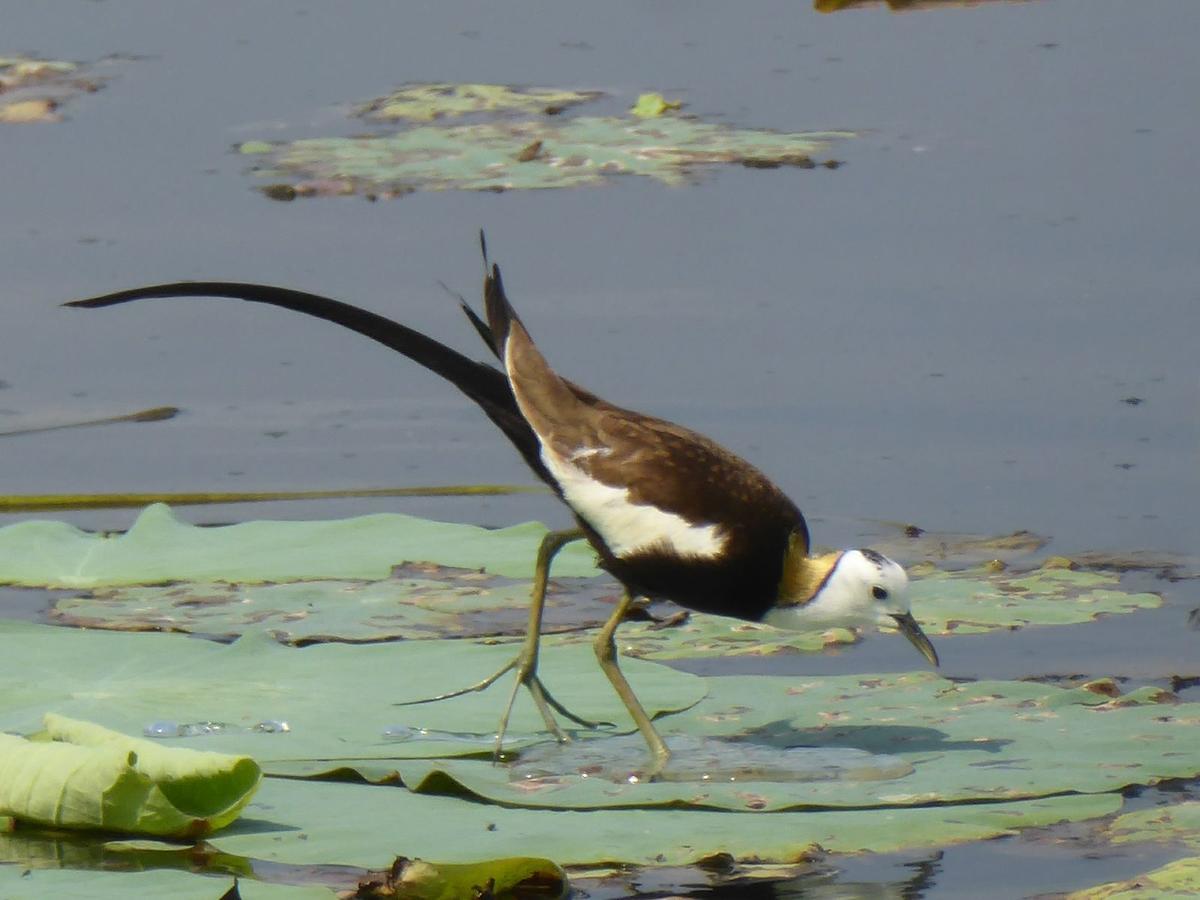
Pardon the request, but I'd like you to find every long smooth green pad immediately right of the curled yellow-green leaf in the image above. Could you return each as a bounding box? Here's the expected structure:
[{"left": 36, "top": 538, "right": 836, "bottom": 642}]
[{"left": 211, "top": 779, "right": 1121, "bottom": 868}]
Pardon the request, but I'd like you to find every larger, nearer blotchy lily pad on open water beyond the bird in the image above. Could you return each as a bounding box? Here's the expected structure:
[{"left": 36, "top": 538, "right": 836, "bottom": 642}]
[{"left": 238, "top": 116, "right": 851, "bottom": 198}]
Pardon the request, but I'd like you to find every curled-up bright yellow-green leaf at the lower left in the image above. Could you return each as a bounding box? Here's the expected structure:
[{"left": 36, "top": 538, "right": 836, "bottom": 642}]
[{"left": 0, "top": 715, "right": 262, "bottom": 838}]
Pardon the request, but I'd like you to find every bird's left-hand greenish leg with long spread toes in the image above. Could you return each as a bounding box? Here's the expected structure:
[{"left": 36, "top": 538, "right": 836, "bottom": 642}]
[{"left": 396, "top": 528, "right": 604, "bottom": 758}]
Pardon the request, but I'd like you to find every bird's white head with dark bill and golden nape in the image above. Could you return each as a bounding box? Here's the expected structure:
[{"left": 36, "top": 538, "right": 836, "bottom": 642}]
[{"left": 763, "top": 548, "right": 938, "bottom": 666}]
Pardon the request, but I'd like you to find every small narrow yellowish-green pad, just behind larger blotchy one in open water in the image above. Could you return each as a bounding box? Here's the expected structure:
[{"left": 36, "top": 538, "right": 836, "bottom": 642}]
[{"left": 355, "top": 84, "right": 604, "bottom": 122}]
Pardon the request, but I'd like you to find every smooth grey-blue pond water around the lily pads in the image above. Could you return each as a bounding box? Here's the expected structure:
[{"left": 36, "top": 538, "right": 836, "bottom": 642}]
[{"left": 0, "top": 0, "right": 1200, "bottom": 896}]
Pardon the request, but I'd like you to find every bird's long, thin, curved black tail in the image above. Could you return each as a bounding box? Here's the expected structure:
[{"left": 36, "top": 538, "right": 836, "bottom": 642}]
[{"left": 64, "top": 283, "right": 558, "bottom": 491}]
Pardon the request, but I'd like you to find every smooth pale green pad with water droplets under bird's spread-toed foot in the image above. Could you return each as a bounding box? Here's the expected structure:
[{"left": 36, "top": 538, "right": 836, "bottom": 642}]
[{"left": 0, "top": 622, "right": 707, "bottom": 772}]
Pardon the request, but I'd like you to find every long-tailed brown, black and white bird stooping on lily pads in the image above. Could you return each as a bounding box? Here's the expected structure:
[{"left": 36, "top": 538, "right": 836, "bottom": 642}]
[{"left": 64, "top": 232, "right": 938, "bottom": 780}]
